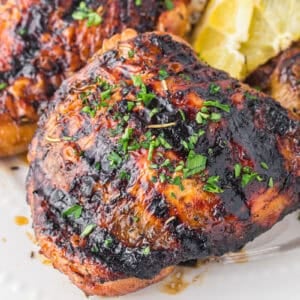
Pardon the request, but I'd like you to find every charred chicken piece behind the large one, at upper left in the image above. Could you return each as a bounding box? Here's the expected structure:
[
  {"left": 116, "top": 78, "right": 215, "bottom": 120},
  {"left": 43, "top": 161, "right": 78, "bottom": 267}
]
[{"left": 0, "top": 0, "right": 189, "bottom": 157}]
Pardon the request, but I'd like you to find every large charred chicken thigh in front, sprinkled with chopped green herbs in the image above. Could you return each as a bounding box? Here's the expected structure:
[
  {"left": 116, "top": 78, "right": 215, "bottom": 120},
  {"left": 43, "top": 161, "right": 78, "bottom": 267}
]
[{"left": 27, "top": 30, "right": 300, "bottom": 296}]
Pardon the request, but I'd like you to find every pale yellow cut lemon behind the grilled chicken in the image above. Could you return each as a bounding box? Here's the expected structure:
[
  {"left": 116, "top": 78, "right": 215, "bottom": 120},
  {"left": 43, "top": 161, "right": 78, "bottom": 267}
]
[{"left": 192, "top": 0, "right": 300, "bottom": 79}]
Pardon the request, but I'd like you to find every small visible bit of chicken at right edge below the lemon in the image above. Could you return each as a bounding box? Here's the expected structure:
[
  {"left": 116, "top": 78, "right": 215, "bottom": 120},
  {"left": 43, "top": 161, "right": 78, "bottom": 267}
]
[{"left": 246, "top": 42, "right": 300, "bottom": 118}]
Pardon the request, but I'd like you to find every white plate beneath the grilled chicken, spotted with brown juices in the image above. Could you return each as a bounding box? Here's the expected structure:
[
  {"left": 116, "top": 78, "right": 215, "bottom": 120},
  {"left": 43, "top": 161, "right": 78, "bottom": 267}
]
[{"left": 0, "top": 158, "right": 300, "bottom": 300}]
